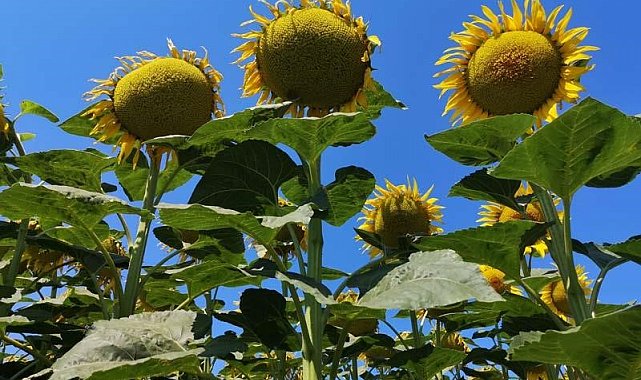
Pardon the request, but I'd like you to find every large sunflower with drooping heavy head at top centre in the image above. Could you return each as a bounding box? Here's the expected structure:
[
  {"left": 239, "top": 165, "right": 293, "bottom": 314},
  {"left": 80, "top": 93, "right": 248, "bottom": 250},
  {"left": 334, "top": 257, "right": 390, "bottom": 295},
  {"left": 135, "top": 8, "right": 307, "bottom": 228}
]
[{"left": 234, "top": 0, "right": 380, "bottom": 117}]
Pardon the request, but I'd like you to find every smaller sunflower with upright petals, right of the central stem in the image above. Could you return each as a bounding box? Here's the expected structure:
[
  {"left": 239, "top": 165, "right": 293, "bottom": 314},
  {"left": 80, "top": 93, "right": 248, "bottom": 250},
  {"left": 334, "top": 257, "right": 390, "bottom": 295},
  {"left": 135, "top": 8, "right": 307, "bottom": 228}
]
[{"left": 357, "top": 180, "right": 443, "bottom": 258}]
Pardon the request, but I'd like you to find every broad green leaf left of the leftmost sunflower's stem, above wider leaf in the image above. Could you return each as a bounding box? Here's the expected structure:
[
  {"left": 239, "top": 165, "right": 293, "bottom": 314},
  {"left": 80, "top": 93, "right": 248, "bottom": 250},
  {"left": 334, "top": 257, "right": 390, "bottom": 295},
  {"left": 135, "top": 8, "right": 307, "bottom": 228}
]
[{"left": 5, "top": 150, "right": 114, "bottom": 192}]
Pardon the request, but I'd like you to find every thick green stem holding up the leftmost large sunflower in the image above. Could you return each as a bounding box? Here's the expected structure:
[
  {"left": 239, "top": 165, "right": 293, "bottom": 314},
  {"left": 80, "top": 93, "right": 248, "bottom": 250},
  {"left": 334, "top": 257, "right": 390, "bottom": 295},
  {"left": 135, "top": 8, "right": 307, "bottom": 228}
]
[{"left": 120, "top": 154, "right": 161, "bottom": 317}]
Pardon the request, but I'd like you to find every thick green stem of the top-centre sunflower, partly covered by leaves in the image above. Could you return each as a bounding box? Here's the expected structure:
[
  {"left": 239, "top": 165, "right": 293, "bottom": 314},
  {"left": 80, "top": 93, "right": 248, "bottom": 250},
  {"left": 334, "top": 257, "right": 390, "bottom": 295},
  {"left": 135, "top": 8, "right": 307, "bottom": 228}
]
[{"left": 303, "top": 158, "right": 325, "bottom": 380}]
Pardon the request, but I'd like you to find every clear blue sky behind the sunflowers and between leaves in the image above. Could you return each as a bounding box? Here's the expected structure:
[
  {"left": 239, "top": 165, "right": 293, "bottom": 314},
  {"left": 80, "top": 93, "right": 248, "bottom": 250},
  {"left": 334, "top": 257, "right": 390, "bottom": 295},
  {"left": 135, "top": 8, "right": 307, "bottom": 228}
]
[{"left": 0, "top": 0, "right": 641, "bottom": 303}]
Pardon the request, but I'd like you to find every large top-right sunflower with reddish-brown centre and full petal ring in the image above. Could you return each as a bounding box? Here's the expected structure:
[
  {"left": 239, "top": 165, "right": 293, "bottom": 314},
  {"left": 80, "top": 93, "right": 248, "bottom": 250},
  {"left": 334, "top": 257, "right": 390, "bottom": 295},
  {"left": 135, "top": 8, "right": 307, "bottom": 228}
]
[{"left": 434, "top": 0, "right": 598, "bottom": 126}]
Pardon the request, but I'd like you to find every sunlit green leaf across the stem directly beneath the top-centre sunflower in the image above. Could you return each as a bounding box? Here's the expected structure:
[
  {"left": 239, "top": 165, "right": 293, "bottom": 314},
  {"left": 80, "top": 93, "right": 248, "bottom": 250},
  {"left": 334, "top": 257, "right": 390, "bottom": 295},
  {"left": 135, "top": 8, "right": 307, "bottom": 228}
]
[{"left": 247, "top": 113, "right": 376, "bottom": 162}]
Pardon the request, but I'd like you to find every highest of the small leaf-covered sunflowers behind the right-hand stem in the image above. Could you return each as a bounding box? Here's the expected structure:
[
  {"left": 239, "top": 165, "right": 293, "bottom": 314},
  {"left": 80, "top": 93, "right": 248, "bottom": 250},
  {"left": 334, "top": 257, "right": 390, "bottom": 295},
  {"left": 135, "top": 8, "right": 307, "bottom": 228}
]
[{"left": 477, "top": 183, "right": 563, "bottom": 257}]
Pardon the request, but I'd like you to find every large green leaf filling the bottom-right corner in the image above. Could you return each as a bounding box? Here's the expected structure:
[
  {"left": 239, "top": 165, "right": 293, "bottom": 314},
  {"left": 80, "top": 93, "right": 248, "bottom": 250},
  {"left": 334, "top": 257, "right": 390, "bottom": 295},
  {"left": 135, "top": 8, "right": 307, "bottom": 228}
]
[{"left": 509, "top": 306, "right": 641, "bottom": 379}]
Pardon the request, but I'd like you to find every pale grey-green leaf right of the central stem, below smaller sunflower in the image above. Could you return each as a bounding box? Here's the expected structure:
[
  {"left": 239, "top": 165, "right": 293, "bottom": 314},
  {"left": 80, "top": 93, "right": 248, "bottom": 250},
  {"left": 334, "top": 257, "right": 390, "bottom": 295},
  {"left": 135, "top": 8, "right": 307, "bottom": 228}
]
[{"left": 359, "top": 250, "right": 502, "bottom": 310}]
